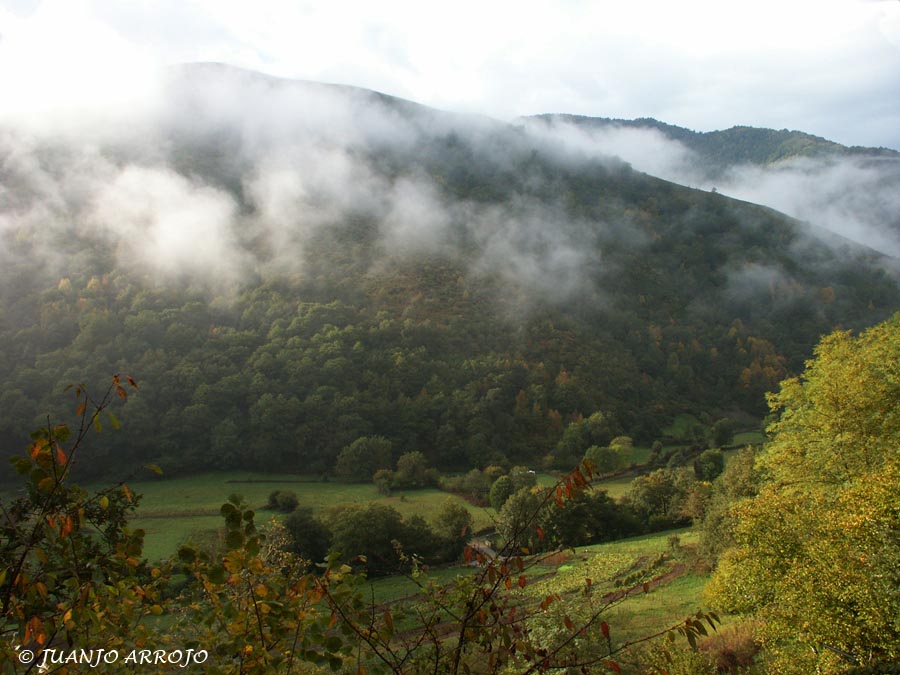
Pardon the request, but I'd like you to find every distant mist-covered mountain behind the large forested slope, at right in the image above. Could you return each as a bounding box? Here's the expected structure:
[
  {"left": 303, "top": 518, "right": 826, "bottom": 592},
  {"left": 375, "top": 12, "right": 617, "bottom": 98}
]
[{"left": 520, "top": 115, "right": 900, "bottom": 257}]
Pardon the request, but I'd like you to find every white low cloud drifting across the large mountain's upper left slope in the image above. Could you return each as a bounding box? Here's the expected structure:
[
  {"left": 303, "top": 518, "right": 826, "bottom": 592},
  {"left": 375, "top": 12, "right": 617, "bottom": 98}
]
[{"left": 0, "top": 64, "right": 602, "bottom": 300}]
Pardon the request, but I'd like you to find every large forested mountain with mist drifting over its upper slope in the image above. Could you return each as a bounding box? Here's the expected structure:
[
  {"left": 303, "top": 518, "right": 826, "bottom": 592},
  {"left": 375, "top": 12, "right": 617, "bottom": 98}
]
[{"left": 0, "top": 64, "right": 900, "bottom": 473}]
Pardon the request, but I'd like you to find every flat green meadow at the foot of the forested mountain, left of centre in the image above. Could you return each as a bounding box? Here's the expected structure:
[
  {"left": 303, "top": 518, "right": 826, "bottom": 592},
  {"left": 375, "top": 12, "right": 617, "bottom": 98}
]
[{"left": 110, "top": 472, "right": 493, "bottom": 561}]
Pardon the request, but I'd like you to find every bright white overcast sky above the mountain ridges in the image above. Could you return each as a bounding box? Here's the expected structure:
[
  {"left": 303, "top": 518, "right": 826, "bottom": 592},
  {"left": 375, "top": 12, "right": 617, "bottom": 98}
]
[{"left": 0, "top": 0, "right": 900, "bottom": 149}]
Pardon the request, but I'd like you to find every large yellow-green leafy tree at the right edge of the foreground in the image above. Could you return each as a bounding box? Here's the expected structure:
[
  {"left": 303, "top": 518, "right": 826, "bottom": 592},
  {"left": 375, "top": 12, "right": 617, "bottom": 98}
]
[{"left": 709, "top": 315, "right": 900, "bottom": 674}]
